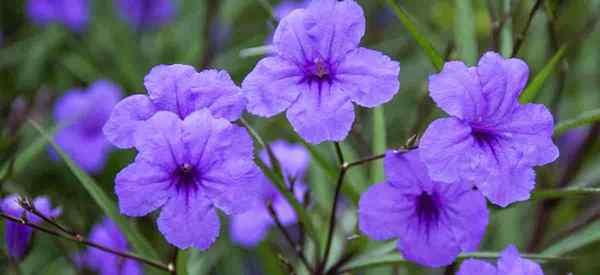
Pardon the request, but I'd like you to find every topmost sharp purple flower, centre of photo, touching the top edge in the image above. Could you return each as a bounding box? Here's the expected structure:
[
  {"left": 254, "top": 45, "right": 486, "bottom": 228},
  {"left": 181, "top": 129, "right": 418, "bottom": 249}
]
[{"left": 242, "top": 0, "right": 400, "bottom": 143}]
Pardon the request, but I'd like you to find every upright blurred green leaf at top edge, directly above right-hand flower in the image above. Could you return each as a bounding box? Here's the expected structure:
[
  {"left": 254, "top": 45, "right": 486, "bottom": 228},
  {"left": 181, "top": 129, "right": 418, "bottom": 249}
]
[{"left": 454, "top": 0, "right": 478, "bottom": 65}]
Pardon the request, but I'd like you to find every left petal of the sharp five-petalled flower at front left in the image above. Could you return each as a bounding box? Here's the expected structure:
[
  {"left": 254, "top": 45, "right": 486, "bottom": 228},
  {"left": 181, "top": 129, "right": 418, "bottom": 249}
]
[{"left": 115, "top": 161, "right": 173, "bottom": 216}]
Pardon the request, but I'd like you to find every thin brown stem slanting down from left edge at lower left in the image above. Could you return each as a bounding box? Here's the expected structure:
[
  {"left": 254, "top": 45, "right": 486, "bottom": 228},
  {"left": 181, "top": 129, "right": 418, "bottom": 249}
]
[{"left": 0, "top": 213, "right": 172, "bottom": 272}]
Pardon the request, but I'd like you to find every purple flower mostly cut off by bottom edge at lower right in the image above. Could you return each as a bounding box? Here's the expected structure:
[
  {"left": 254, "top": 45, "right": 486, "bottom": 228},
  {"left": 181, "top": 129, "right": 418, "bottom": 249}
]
[{"left": 456, "top": 245, "right": 544, "bottom": 275}]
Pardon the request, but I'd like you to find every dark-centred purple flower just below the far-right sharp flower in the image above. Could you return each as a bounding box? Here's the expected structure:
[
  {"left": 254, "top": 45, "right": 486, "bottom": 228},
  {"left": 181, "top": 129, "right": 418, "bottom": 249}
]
[{"left": 358, "top": 149, "right": 488, "bottom": 267}]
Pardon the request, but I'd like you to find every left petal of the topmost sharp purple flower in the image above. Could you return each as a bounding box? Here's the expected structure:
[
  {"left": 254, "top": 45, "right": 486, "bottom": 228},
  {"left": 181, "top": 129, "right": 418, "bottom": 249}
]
[{"left": 242, "top": 57, "right": 305, "bottom": 117}]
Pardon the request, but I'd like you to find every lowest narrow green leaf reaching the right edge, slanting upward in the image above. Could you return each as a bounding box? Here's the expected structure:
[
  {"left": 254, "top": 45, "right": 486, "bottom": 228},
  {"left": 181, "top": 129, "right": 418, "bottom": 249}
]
[{"left": 542, "top": 221, "right": 600, "bottom": 255}]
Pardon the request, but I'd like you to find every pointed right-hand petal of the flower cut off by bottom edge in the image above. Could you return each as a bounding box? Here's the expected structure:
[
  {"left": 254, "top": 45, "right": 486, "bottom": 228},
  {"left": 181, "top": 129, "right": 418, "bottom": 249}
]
[{"left": 498, "top": 245, "right": 544, "bottom": 275}]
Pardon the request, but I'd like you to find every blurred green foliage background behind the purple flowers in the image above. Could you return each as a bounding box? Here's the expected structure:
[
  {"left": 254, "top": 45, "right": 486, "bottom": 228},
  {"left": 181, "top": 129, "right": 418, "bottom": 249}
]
[{"left": 0, "top": 0, "right": 600, "bottom": 275}]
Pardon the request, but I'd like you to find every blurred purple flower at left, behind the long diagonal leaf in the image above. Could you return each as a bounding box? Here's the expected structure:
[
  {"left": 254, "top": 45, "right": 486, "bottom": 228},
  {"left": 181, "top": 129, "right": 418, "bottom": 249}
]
[{"left": 54, "top": 80, "right": 122, "bottom": 172}]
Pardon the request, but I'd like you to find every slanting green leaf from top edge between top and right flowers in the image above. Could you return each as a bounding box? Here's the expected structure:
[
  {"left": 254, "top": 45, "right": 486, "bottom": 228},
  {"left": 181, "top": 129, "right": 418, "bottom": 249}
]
[{"left": 386, "top": 0, "right": 444, "bottom": 71}]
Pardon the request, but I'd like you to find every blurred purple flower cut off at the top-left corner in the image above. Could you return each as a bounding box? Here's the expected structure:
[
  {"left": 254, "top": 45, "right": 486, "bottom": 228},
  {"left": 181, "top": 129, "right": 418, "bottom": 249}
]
[{"left": 27, "top": 0, "right": 89, "bottom": 32}]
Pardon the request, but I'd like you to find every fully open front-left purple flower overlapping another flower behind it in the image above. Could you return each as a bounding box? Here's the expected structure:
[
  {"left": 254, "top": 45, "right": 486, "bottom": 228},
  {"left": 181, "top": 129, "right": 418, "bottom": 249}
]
[{"left": 115, "top": 109, "right": 262, "bottom": 250}]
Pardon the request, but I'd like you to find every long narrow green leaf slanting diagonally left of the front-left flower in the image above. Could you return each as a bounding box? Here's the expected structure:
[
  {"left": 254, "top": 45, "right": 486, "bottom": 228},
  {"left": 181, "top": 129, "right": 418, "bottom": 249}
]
[{"left": 29, "top": 120, "right": 158, "bottom": 264}]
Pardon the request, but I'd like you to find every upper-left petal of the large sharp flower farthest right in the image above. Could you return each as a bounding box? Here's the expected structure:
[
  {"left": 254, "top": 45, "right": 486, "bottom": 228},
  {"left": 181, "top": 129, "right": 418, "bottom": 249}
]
[{"left": 429, "top": 61, "right": 484, "bottom": 119}]
